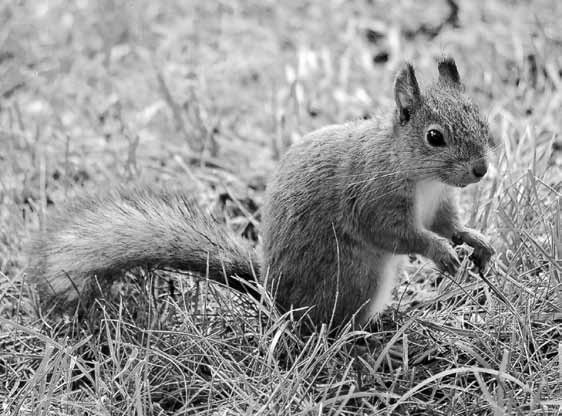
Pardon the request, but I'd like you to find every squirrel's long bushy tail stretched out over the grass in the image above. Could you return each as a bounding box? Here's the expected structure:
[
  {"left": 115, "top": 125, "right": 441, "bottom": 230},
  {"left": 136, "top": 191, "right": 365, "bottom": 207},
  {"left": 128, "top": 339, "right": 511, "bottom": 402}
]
[{"left": 27, "top": 187, "right": 258, "bottom": 308}]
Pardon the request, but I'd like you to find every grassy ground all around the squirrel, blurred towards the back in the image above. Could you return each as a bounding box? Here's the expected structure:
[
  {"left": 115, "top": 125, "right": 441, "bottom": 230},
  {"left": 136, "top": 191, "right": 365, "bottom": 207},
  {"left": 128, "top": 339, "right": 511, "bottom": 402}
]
[{"left": 0, "top": 0, "right": 562, "bottom": 415}]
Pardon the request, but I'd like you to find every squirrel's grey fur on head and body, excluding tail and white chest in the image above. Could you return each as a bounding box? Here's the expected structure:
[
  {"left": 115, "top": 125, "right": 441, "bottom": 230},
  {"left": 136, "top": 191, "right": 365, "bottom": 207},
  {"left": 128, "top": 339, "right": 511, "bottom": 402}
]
[{"left": 263, "top": 57, "right": 491, "bottom": 323}]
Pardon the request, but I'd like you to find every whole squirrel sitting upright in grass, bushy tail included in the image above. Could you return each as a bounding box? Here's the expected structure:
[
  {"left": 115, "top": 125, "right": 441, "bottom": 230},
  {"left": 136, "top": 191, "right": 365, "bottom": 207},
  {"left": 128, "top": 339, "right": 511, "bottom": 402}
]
[{"left": 27, "top": 56, "right": 494, "bottom": 326}]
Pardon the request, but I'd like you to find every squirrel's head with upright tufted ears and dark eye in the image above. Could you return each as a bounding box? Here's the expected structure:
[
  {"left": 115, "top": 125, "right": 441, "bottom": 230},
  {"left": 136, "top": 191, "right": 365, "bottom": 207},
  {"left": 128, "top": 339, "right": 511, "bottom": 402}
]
[{"left": 394, "top": 57, "right": 493, "bottom": 186}]
